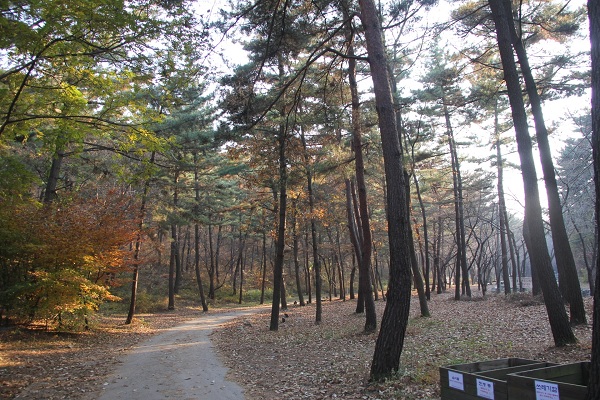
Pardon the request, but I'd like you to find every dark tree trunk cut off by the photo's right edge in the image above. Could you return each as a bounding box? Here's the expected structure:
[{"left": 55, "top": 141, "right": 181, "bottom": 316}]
[{"left": 586, "top": 0, "right": 600, "bottom": 400}]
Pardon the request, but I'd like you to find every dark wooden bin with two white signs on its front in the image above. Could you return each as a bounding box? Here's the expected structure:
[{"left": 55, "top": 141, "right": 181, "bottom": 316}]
[{"left": 440, "top": 358, "right": 553, "bottom": 400}]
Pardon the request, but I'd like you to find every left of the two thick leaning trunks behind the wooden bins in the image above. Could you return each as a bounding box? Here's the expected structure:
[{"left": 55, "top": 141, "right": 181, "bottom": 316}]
[{"left": 489, "top": 0, "right": 577, "bottom": 346}]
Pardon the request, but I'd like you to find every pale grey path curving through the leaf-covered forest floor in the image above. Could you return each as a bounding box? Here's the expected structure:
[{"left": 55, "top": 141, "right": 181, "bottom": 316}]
[{"left": 99, "top": 308, "right": 261, "bottom": 400}]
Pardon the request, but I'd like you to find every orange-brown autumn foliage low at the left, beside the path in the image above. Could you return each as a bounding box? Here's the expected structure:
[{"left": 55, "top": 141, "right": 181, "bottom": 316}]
[{"left": 0, "top": 192, "right": 136, "bottom": 324}]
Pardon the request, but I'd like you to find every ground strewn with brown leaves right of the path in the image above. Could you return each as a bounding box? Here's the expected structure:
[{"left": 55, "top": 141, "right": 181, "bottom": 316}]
[{"left": 213, "top": 294, "right": 592, "bottom": 399}]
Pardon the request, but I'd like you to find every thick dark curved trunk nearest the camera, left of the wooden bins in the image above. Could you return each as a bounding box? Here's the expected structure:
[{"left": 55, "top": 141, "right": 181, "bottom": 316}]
[{"left": 359, "top": 0, "right": 411, "bottom": 379}]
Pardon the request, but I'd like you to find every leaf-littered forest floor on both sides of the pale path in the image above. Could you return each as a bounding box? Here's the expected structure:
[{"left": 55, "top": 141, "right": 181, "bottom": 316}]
[{"left": 0, "top": 292, "right": 592, "bottom": 400}]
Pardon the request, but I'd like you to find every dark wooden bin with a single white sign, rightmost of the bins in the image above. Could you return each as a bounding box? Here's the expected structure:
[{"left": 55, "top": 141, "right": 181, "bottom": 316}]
[{"left": 508, "top": 362, "right": 590, "bottom": 400}]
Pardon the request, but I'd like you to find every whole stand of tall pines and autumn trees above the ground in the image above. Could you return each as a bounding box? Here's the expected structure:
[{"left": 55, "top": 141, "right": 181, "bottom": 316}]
[{"left": 0, "top": 0, "right": 600, "bottom": 398}]
